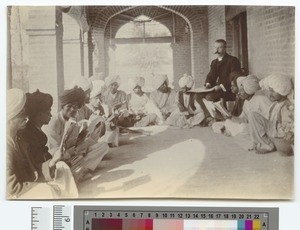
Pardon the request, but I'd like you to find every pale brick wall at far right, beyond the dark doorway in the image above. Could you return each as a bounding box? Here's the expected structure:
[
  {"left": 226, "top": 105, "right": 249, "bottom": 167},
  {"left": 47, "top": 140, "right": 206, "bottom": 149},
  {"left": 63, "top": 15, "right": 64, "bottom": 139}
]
[{"left": 247, "top": 7, "right": 295, "bottom": 78}]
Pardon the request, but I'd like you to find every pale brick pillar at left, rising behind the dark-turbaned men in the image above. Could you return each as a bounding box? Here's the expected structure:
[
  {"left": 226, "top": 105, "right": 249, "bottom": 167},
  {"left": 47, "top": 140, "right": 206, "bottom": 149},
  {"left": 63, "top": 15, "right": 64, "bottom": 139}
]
[{"left": 27, "top": 6, "right": 64, "bottom": 110}]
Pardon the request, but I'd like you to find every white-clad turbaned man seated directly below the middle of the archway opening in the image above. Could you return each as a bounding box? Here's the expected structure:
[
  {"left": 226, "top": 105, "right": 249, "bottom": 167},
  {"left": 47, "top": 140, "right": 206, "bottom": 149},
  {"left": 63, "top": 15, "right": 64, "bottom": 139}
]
[{"left": 127, "top": 77, "right": 160, "bottom": 127}]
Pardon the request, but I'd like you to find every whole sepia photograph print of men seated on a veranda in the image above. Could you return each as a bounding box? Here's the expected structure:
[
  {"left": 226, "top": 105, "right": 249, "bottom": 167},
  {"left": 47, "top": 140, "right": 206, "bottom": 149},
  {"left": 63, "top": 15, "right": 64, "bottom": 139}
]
[{"left": 6, "top": 5, "right": 295, "bottom": 200}]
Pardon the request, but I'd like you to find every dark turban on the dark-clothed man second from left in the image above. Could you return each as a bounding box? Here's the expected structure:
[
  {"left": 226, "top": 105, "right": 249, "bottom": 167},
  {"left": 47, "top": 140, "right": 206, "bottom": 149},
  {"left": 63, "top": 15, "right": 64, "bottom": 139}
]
[{"left": 25, "top": 89, "right": 53, "bottom": 118}]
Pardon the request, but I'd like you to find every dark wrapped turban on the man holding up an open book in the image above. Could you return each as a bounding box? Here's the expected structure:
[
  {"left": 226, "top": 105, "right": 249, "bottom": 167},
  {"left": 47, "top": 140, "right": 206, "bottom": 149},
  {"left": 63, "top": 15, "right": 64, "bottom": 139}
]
[{"left": 59, "top": 86, "right": 85, "bottom": 107}]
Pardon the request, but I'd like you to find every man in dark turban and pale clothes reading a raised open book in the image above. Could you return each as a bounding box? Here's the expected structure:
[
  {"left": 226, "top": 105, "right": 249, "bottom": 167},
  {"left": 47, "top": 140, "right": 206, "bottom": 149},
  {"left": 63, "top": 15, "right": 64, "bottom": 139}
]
[{"left": 47, "top": 87, "right": 109, "bottom": 181}]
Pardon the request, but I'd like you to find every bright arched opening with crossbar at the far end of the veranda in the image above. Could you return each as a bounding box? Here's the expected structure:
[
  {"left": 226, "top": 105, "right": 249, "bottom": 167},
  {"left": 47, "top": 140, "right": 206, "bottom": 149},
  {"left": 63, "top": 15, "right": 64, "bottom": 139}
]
[{"left": 109, "top": 15, "right": 174, "bottom": 92}]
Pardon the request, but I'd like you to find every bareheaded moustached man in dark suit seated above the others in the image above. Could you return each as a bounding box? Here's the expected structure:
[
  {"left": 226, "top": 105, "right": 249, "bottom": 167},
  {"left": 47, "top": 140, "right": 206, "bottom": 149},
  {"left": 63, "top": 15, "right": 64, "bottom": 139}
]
[{"left": 197, "top": 39, "right": 241, "bottom": 125}]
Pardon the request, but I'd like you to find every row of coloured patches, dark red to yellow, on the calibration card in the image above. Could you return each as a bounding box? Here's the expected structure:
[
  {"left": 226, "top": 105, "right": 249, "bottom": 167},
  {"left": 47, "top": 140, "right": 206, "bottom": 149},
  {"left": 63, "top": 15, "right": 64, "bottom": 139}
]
[{"left": 91, "top": 218, "right": 262, "bottom": 230}]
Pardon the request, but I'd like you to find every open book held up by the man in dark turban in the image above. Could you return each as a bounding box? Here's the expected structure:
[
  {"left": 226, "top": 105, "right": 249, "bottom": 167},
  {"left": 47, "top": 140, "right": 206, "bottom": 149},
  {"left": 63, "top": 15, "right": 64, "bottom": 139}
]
[{"left": 60, "top": 116, "right": 103, "bottom": 152}]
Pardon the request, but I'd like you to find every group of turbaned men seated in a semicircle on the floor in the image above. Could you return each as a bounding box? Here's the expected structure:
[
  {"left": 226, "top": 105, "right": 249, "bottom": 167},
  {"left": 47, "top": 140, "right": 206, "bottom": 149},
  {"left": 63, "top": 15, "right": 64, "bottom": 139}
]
[{"left": 7, "top": 38, "right": 294, "bottom": 199}]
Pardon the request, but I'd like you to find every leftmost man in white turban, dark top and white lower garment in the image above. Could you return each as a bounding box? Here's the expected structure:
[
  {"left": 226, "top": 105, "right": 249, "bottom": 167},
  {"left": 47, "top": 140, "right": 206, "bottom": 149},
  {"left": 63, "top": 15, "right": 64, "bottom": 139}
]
[{"left": 6, "top": 88, "right": 78, "bottom": 199}]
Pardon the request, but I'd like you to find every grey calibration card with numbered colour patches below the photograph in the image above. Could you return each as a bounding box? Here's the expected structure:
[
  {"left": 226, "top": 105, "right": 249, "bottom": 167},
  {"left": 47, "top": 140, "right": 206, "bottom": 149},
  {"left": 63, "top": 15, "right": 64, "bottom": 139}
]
[{"left": 74, "top": 206, "right": 279, "bottom": 230}]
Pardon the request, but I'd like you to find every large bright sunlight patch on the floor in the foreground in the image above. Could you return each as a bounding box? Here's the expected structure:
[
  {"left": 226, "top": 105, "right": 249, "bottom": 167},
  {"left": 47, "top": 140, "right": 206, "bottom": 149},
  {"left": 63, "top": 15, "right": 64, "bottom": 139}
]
[{"left": 97, "top": 139, "right": 205, "bottom": 197}]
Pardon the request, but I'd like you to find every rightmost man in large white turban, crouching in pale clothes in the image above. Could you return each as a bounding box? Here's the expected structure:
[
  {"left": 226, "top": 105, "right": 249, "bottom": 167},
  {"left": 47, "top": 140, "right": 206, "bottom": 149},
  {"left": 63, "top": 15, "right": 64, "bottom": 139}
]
[{"left": 249, "top": 75, "right": 294, "bottom": 155}]
